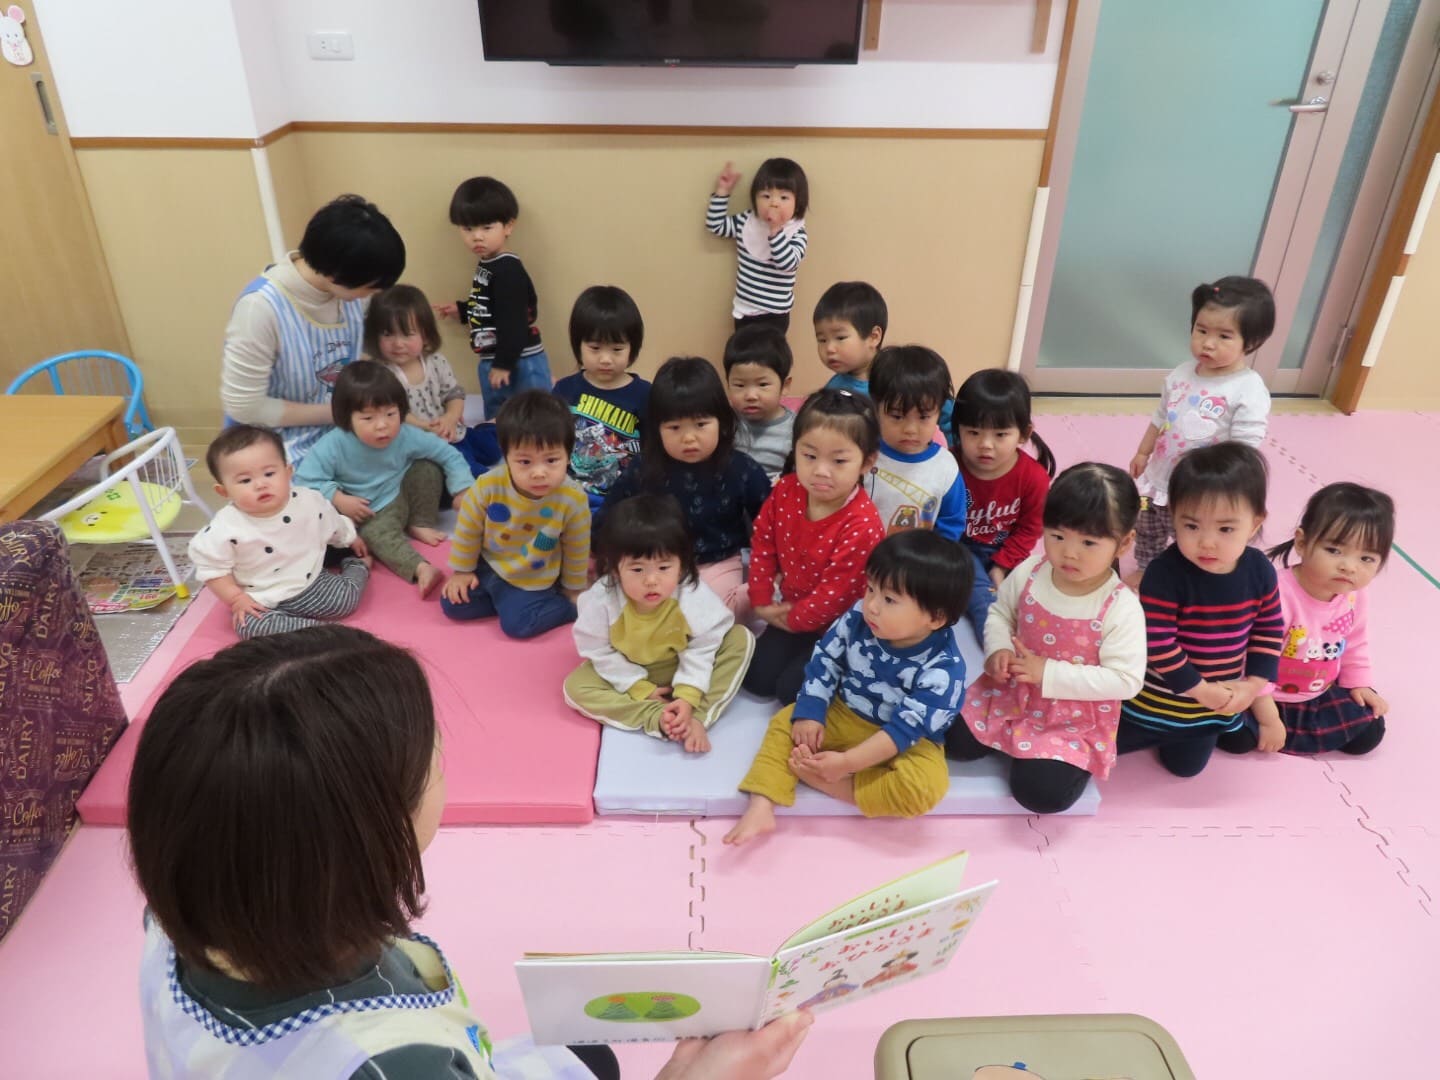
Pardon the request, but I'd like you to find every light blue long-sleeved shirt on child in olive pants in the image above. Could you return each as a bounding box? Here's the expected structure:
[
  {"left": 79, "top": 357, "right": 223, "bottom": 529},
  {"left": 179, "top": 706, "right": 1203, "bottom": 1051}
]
[{"left": 295, "top": 423, "right": 475, "bottom": 510}]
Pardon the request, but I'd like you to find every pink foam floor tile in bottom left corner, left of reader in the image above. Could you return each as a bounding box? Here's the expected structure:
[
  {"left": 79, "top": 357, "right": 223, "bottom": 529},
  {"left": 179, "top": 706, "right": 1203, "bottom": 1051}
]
[{"left": 0, "top": 828, "right": 145, "bottom": 1080}]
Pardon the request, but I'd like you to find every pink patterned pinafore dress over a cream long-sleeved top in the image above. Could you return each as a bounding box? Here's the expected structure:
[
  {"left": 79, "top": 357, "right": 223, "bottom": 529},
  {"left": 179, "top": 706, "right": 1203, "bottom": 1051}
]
[{"left": 960, "top": 559, "right": 1125, "bottom": 780}]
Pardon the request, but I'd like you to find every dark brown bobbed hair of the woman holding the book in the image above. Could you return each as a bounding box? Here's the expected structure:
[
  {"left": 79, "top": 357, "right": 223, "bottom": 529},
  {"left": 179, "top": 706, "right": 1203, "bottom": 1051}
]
[{"left": 127, "top": 625, "right": 435, "bottom": 994}]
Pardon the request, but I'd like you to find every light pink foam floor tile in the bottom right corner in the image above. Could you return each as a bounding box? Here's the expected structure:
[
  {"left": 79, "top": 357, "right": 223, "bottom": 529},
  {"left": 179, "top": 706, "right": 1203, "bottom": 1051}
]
[{"left": 1031, "top": 821, "right": 1440, "bottom": 1077}]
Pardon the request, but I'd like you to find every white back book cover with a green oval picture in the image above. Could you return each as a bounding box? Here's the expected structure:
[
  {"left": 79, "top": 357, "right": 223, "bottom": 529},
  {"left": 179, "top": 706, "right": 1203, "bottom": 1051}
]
[{"left": 516, "top": 952, "right": 770, "bottom": 1045}]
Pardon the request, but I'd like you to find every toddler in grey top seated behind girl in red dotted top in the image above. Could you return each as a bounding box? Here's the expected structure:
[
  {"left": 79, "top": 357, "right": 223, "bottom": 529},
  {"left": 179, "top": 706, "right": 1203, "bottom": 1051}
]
[{"left": 724, "top": 325, "right": 795, "bottom": 484}]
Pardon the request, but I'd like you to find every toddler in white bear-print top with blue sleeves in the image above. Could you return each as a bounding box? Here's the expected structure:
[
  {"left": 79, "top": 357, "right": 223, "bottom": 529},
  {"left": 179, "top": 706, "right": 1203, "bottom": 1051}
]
[{"left": 864, "top": 346, "right": 965, "bottom": 541}]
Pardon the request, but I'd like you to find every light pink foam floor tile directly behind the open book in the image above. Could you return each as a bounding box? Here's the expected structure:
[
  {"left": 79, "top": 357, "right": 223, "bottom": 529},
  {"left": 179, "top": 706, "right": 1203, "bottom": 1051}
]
[{"left": 698, "top": 818, "right": 1099, "bottom": 1077}]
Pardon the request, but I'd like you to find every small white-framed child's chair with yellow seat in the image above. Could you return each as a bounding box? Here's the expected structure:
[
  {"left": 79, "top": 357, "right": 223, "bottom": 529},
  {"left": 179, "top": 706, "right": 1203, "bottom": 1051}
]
[{"left": 42, "top": 428, "right": 215, "bottom": 599}]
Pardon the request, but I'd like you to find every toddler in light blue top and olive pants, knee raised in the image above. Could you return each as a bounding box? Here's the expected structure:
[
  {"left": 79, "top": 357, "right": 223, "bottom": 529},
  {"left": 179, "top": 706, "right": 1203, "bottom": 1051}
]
[{"left": 295, "top": 360, "right": 471, "bottom": 596}]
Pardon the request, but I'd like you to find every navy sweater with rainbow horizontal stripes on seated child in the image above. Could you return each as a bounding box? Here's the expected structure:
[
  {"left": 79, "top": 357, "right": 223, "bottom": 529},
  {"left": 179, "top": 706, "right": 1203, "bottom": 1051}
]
[{"left": 1120, "top": 544, "right": 1284, "bottom": 737}]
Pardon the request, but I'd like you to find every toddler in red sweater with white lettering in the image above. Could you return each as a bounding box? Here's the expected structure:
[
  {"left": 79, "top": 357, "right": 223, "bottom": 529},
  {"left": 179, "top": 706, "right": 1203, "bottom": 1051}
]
[{"left": 953, "top": 367, "right": 1056, "bottom": 639}]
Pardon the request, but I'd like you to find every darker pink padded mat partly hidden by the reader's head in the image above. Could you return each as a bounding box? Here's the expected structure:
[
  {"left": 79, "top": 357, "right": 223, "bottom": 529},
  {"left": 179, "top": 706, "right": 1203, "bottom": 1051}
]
[{"left": 79, "top": 546, "right": 600, "bottom": 825}]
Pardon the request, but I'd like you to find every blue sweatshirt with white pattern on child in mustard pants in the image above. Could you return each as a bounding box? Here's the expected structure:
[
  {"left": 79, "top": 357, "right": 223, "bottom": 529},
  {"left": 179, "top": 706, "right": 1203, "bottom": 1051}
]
[{"left": 791, "top": 600, "right": 965, "bottom": 753}]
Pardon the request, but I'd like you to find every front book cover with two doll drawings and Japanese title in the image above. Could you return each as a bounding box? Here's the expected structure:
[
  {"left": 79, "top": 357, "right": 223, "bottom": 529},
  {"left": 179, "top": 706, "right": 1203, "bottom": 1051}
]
[{"left": 760, "top": 881, "right": 996, "bottom": 1024}]
